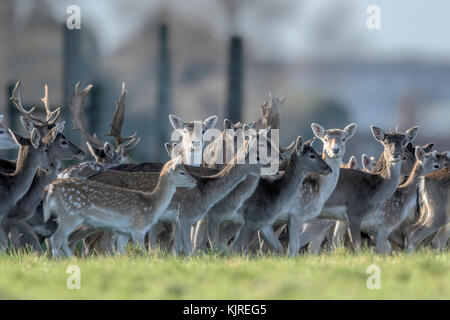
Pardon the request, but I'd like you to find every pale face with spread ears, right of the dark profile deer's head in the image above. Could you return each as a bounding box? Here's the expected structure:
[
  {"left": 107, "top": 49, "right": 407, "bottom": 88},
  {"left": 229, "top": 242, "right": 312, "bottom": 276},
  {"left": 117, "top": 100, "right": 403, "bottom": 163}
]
[{"left": 311, "top": 123, "right": 358, "bottom": 159}]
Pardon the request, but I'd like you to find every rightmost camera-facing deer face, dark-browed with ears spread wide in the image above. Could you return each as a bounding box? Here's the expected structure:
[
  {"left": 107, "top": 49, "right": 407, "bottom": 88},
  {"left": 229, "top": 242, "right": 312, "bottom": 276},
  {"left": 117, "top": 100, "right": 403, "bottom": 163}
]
[{"left": 371, "top": 126, "right": 419, "bottom": 164}]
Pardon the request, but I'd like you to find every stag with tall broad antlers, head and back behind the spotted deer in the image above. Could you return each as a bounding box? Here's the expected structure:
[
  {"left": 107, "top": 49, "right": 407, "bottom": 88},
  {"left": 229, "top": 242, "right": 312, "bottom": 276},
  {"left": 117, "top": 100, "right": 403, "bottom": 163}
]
[{"left": 58, "top": 82, "right": 140, "bottom": 178}]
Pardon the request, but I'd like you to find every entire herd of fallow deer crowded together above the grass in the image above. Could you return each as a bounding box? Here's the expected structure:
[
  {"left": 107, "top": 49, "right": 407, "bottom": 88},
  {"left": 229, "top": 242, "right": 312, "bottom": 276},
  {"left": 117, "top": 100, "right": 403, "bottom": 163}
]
[{"left": 0, "top": 82, "right": 450, "bottom": 257}]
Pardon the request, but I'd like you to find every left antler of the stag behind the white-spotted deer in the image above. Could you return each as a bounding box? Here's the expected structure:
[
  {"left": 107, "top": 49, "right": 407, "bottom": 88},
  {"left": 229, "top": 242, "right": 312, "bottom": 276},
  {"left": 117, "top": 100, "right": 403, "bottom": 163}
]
[{"left": 70, "top": 82, "right": 103, "bottom": 147}]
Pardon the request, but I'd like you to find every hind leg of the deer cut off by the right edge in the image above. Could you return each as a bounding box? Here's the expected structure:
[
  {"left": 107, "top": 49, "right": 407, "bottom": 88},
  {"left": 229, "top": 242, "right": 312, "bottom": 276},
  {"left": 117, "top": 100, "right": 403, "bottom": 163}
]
[{"left": 407, "top": 207, "right": 447, "bottom": 252}]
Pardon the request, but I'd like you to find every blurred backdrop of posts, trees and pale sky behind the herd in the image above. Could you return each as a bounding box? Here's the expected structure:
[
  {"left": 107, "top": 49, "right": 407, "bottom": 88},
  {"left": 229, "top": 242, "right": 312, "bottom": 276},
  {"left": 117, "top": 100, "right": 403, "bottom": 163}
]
[{"left": 0, "top": 0, "right": 450, "bottom": 161}]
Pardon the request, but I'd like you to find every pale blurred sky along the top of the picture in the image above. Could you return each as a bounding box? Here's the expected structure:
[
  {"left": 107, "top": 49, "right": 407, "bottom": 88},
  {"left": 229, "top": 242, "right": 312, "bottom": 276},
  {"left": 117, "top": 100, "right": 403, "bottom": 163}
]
[{"left": 10, "top": 0, "right": 450, "bottom": 62}]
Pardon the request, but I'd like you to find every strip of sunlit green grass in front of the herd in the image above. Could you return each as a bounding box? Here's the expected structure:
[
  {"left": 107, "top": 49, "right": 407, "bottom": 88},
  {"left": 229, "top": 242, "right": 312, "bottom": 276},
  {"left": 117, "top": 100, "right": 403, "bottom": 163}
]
[{"left": 0, "top": 250, "right": 450, "bottom": 299}]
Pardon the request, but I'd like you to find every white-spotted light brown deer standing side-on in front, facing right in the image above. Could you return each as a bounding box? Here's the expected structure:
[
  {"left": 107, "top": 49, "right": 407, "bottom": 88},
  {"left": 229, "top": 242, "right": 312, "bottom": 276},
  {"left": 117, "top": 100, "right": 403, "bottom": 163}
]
[{"left": 44, "top": 156, "right": 197, "bottom": 257}]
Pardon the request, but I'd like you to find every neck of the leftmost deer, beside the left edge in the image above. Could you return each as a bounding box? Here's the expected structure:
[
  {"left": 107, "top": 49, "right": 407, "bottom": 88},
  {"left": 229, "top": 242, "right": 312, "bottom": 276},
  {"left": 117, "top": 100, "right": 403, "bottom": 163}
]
[{"left": 9, "top": 146, "right": 38, "bottom": 199}]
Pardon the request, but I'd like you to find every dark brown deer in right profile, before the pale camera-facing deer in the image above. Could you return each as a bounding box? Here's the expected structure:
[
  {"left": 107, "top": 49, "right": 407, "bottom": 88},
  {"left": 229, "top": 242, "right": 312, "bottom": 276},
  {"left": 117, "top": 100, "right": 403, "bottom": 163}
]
[{"left": 231, "top": 137, "right": 332, "bottom": 253}]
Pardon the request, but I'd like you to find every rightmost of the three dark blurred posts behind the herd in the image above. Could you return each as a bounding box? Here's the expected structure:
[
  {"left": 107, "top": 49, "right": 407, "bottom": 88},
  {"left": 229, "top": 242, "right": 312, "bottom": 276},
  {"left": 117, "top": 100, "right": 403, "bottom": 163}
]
[{"left": 226, "top": 36, "right": 244, "bottom": 122}]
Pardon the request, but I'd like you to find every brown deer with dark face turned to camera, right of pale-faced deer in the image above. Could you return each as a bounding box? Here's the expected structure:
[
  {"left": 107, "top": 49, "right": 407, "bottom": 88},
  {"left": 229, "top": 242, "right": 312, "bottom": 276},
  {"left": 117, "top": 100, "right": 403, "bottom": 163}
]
[{"left": 319, "top": 126, "right": 419, "bottom": 251}]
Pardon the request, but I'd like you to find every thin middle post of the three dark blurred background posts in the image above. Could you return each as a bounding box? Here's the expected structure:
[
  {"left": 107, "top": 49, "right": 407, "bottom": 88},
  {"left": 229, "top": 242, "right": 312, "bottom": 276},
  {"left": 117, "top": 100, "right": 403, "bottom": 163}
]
[{"left": 155, "top": 23, "right": 172, "bottom": 159}]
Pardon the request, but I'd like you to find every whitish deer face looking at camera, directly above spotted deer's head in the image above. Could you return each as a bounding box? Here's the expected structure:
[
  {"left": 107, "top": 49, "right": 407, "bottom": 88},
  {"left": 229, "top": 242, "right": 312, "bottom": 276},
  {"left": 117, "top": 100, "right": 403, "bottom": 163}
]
[{"left": 169, "top": 114, "right": 217, "bottom": 165}]
